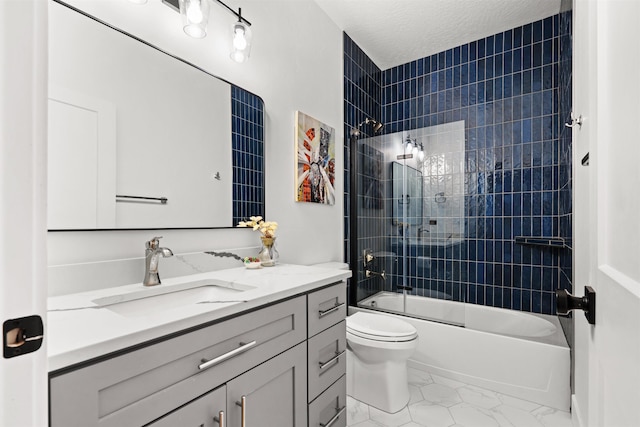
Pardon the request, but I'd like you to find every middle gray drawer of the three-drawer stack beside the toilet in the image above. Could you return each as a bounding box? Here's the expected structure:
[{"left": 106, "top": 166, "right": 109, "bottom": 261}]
[{"left": 307, "top": 320, "right": 347, "bottom": 401}]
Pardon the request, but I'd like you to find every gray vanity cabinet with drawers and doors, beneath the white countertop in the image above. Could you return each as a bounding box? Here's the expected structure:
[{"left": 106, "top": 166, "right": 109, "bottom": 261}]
[{"left": 49, "top": 282, "right": 346, "bottom": 427}]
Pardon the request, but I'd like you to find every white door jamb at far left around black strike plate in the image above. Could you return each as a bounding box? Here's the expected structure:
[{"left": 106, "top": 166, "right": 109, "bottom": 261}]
[{"left": 0, "top": 0, "right": 48, "bottom": 427}]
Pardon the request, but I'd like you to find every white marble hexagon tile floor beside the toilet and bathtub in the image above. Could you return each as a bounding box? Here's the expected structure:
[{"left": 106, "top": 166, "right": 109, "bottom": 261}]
[{"left": 347, "top": 368, "right": 571, "bottom": 427}]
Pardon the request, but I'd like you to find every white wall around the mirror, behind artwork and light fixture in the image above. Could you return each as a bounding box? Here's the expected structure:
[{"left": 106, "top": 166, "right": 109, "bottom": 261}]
[{"left": 49, "top": 0, "right": 344, "bottom": 288}]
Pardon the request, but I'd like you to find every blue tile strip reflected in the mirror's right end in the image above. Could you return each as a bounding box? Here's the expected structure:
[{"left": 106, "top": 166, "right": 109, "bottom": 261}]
[{"left": 231, "top": 85, "right": 265, "bottom": 225}]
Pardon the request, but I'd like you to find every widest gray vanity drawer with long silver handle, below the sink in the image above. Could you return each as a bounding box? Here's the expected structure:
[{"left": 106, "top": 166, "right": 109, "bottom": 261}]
[{"left": 50, "top": 296, "right": 306, "bottom": 427}]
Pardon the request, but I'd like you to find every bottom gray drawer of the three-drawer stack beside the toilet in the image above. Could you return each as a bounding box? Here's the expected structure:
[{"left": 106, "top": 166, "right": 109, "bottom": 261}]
[{"left": 309, "top": 375, "right": 347, "bottom": 427}]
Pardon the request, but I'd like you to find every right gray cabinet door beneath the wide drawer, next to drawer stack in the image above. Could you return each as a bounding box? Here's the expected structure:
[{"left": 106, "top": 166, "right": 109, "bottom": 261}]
[{"left": 225, "top": 343, "right": 307, "bottom": 427}]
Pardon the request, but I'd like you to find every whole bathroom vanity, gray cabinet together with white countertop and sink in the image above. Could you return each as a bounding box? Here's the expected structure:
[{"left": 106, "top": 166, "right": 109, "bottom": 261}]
[{"left": 48, "top": 265, "right": 351, "bottom": 427}]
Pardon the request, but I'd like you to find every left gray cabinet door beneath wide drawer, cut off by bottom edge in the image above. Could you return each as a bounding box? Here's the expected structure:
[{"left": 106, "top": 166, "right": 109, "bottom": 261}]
[{"left": 147, "top": 386, "right": 227, "bottom": 427}]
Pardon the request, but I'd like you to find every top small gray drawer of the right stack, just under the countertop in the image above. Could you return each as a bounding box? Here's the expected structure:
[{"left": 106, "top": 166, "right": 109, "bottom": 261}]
[{"left": 307, "top": 281, "right": 347, "bottom": 337}]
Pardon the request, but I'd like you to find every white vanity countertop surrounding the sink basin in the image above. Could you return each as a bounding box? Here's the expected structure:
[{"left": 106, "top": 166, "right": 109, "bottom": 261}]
[{"left": 47, "top": 265, "right": 351, "bottom": 372}]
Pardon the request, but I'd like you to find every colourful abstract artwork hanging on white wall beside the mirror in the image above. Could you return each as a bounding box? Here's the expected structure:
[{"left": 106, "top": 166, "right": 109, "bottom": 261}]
[{"left": 295, "top": 111, "right": 336, "bottom": 205}]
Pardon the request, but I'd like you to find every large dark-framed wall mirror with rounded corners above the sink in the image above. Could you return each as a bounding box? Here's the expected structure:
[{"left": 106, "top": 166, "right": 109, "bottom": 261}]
[{"left": 48, "top": 1, "right": 264, "bottom": 230}]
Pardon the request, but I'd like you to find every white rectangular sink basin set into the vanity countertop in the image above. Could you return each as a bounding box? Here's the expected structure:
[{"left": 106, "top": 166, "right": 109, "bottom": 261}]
[{"left": 92, "top": 279, "right": 255, "bottom": 317}]
